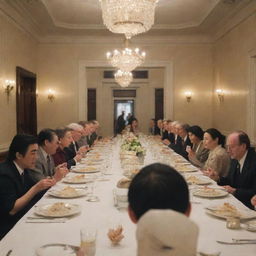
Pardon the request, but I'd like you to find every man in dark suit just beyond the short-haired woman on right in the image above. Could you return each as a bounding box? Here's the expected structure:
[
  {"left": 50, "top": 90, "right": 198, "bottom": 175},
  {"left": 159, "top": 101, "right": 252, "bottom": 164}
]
[{"left": 169, "top": 123, "right": 192, "bottom": 159}]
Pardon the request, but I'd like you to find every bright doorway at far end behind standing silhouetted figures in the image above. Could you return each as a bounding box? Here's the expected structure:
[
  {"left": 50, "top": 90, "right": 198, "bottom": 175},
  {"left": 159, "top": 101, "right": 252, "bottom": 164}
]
[{"left": 114, "top": 99, "right": 134, "bottom": 133}]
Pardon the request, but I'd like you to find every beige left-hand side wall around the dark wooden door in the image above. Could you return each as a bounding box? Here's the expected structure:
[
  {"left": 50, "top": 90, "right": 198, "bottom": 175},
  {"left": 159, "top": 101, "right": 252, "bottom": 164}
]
[{"left": 0, "top": 12, "right": 37, "bottom": 151}]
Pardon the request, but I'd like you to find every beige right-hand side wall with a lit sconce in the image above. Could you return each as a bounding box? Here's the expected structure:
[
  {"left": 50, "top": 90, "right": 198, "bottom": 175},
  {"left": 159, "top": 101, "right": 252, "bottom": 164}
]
[{"left": 213, "top": 14, "right": 256, "bottom": 134}]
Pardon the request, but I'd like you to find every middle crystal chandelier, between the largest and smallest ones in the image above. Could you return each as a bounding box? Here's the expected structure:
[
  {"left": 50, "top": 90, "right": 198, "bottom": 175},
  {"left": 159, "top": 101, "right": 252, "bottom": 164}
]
[{"left": 107, "top": 48, "right": 146, "bottom": 72}]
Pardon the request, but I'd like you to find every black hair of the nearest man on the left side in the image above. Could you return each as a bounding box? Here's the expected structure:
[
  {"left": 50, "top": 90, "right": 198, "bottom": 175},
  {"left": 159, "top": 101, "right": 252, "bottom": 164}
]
[{"left": 7, "top": 134, "right": 37, "bottom": 161}]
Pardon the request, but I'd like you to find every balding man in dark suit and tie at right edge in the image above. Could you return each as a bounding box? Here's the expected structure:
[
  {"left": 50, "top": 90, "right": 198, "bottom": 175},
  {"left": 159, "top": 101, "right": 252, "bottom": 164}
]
[{"left": 209, "top": 131, "right": 256, "bottom": 209}]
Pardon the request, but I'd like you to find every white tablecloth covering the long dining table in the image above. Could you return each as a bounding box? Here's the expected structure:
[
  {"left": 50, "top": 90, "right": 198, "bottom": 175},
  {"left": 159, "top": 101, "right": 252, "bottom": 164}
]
[{"left": 0, "top": 136, "right": 256, "bottom": 256}]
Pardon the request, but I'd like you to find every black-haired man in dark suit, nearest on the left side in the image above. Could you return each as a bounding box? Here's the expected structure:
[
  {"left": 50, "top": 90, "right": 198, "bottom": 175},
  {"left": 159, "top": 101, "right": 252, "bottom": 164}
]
[{"left": 0, "top": 135, "right": 55, "bottom": 239}]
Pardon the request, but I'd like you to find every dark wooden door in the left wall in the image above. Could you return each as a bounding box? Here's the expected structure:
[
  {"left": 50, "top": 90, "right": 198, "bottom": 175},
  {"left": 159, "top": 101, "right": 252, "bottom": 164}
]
[{"left": 16, "top": 67, "right": 37, "bottom": 136}]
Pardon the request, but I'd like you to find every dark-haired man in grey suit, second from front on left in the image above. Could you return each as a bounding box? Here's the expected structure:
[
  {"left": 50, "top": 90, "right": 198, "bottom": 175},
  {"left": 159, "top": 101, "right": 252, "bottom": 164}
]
[{"left": 28, "top": 129, "right": 68, "bottom": 182}]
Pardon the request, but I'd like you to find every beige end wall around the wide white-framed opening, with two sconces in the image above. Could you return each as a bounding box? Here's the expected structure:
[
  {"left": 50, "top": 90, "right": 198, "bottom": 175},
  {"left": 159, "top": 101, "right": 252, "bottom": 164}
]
[{"left": 37, "top": 44, "right": 213, "bottom": 136}]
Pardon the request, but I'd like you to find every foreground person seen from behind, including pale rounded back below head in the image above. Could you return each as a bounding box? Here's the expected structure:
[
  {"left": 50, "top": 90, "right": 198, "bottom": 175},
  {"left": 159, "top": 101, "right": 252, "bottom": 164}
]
[{"left": 128, "top": 164, "right": 198, "bottom": 256}]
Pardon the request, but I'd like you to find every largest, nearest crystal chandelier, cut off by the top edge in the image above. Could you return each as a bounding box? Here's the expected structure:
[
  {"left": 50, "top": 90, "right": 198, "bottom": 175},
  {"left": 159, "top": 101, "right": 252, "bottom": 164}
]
[{"left": 99, "top": 0, "right": 158, "bottom": 39}]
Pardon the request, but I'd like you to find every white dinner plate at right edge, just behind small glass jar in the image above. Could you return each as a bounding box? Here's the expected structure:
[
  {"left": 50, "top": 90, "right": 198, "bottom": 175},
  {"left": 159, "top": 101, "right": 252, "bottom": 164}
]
[{"left": 206, "top": 205, "right": 256, "bottom": 220}]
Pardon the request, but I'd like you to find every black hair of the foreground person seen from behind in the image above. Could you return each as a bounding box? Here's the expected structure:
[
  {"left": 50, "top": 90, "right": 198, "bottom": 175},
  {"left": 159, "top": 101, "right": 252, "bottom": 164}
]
[{"left": 128, "top": 163, "right": 189, "bottom": 219}]
